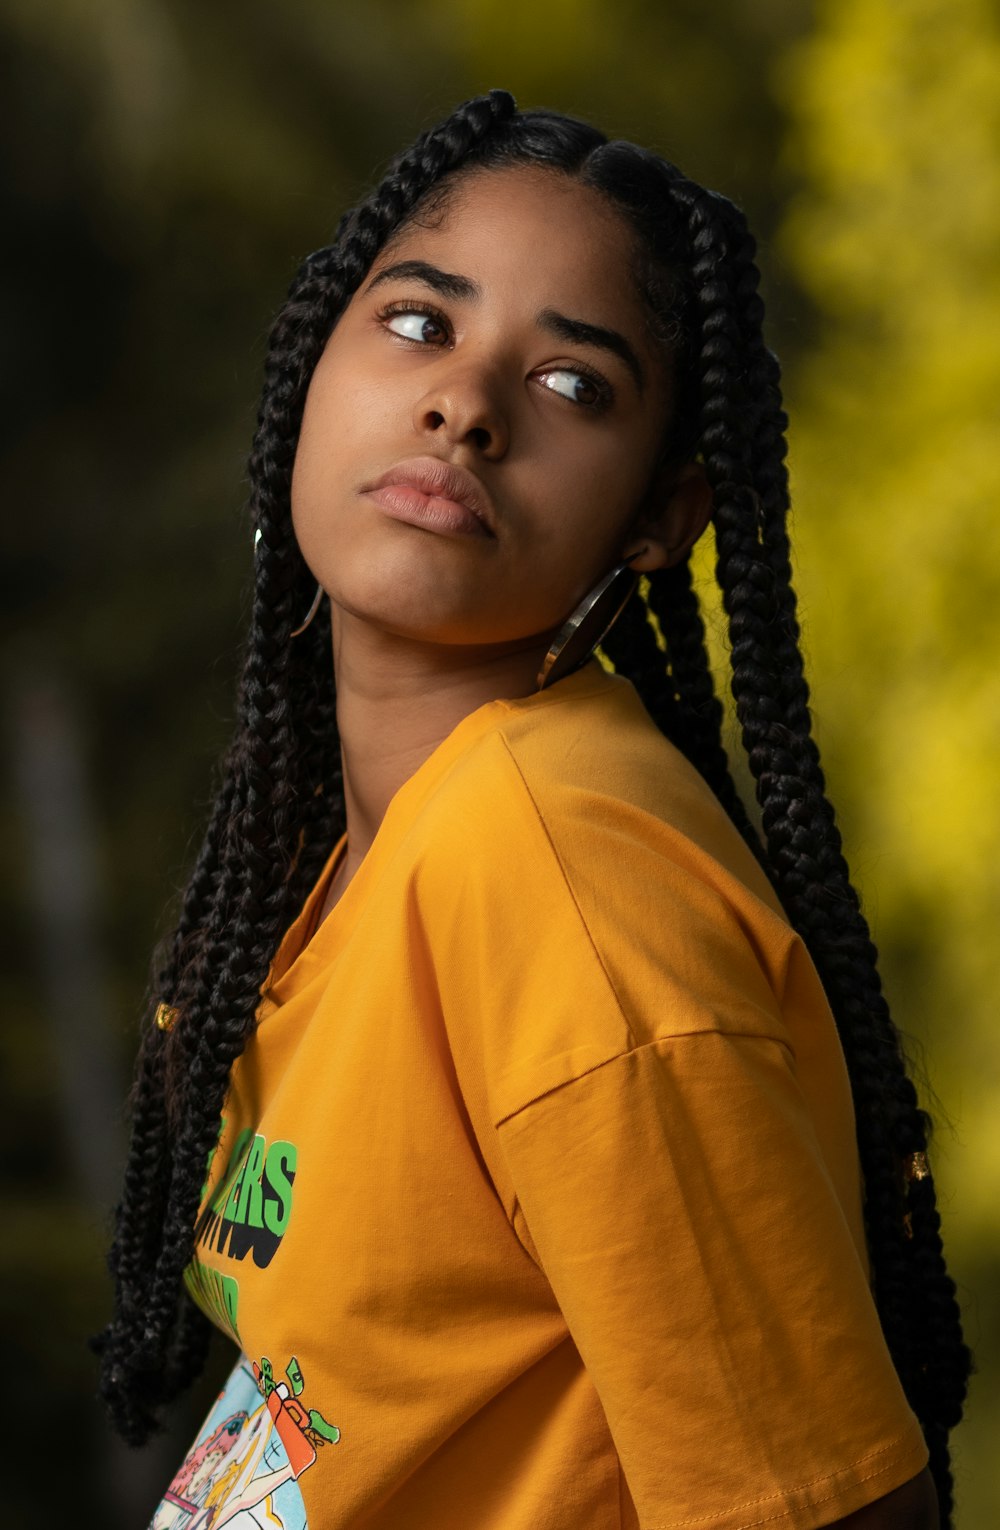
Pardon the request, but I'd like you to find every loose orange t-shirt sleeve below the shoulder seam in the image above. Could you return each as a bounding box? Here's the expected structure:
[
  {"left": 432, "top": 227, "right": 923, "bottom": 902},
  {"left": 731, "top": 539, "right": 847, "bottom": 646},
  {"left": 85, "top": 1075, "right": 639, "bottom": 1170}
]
[{"left": 497, "top": 1030, "right": 927, "bottom": 1530}]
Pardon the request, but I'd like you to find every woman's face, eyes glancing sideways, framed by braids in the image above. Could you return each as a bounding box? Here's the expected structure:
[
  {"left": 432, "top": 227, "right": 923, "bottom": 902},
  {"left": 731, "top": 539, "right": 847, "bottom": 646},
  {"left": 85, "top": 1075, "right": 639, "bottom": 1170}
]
[{"left": 292, "top": 167, "right": 691, "bottom": 652}]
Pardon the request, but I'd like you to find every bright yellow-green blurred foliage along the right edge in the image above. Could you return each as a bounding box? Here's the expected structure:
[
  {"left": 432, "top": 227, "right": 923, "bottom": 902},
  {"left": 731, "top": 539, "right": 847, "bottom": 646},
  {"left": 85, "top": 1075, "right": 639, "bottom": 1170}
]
[{"left": 781, "top": 0, "right": 1000, "bottom": 1525}]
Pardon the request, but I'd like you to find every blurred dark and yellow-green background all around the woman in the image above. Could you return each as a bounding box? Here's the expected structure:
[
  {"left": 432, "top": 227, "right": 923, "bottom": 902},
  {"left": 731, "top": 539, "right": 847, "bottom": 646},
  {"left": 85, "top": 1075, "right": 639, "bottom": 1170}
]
[{"left": 0, "top": 0, "right": 1000, "bottom": 1530}]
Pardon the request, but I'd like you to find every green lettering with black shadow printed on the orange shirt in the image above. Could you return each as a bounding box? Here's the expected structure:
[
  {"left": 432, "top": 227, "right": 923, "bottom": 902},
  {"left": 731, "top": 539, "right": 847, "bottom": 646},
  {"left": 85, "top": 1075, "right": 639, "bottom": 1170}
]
[{"left": 183, "top": 1118, "right": 298, "bottom": 1343}]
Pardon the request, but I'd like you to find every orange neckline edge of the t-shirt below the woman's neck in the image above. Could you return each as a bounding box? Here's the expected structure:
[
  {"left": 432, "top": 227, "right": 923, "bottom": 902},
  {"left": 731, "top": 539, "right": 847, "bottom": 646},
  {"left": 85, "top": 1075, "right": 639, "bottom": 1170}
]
[{"left": 258, "top": 656, "right": 631, "bottom": 1019}]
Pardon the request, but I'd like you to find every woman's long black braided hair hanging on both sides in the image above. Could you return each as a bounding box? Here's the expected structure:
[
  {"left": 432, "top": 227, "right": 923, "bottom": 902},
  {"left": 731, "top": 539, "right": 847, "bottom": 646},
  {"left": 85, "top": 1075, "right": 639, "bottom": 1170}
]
[{"left": 95, "top": 90, "right": 971, "bottom": 1530}]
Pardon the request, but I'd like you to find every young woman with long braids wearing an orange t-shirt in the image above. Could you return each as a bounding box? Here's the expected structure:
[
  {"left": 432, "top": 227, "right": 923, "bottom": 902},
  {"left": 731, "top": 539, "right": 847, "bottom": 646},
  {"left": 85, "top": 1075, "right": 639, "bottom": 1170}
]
[{"left": 101, "top": 90, "right": 968, "bottom": 1530}]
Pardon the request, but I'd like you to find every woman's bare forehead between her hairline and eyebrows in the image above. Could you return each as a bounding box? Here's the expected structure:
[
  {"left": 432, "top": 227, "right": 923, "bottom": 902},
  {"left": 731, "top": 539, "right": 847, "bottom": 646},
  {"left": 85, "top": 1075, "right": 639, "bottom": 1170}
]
[{"left": 370, "top": 165, "right": 644, "bottom": 327}]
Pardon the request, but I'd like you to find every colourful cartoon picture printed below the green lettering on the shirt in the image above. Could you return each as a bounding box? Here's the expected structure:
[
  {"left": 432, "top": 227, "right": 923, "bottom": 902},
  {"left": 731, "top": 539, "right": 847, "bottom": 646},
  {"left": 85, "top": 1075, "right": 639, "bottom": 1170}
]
[{"left": 150, "top": 1356, "right": 341, "bottom": 1530}]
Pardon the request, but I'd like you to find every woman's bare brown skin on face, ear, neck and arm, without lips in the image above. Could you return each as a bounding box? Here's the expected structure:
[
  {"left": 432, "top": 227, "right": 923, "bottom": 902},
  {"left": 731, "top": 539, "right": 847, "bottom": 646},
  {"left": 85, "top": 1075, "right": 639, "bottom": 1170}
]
[{"left": 292, "top": 167, "right": 939, "bottom": 1530}]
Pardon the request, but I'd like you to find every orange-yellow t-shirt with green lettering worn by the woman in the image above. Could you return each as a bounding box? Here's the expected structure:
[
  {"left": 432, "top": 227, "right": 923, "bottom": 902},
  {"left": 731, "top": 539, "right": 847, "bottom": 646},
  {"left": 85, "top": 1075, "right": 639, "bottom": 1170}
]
[{"left": 154, "top": 659, "right": 927, "bottom": 1530}]
